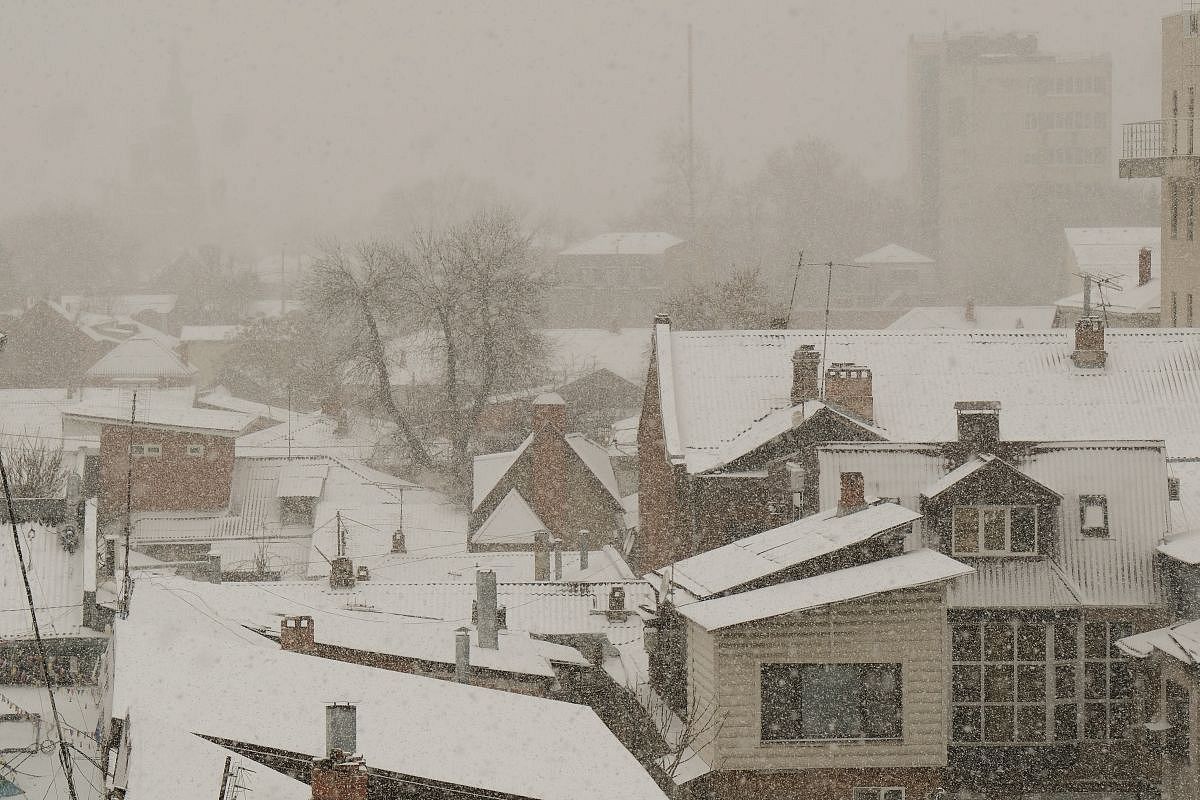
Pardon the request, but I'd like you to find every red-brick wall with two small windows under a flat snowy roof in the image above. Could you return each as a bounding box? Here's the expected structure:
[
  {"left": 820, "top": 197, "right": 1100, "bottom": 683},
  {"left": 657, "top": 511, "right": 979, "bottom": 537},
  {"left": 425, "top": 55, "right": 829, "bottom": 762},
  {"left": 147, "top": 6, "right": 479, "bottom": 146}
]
[{"left": 98, "top": 425, "right": 234, "bottom": 522}]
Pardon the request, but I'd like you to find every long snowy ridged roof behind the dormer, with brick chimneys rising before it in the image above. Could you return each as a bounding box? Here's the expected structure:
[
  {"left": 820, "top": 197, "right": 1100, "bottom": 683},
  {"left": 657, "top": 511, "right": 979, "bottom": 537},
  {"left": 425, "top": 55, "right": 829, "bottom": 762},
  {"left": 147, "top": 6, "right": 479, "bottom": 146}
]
[{"left": 655, "top": 325, "right": 1200, "bottom": 471}]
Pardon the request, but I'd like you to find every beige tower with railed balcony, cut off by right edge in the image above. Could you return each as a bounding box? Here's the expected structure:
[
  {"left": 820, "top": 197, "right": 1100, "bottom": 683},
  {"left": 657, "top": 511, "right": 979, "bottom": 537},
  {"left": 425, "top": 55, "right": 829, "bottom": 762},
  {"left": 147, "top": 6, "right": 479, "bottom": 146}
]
[{"left": 1120, "top": 2, "right": 1200, "bottom": 327}]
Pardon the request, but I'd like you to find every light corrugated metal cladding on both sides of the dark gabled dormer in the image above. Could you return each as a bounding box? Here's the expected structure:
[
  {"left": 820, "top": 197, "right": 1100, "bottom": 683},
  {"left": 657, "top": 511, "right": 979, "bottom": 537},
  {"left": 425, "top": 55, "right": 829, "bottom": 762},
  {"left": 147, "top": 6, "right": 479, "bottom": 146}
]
[{"left": 818, "top": 441, "right": 1169, "bottom": 607}]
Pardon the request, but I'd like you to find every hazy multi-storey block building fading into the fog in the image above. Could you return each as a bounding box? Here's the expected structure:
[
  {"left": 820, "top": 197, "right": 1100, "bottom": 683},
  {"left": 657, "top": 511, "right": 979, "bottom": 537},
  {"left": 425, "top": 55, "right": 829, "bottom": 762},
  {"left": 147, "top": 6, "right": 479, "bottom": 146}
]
[{"left": 908, "top": 34, "right": 1116, "bottom": 305}]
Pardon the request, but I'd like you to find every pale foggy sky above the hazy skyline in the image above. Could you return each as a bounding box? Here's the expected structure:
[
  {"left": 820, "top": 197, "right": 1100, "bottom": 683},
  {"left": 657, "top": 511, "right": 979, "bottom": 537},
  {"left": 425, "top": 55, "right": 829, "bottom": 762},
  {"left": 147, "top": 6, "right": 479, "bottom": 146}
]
[{"left": 0, "top": 0, "right": 1180, "bottom": 240}]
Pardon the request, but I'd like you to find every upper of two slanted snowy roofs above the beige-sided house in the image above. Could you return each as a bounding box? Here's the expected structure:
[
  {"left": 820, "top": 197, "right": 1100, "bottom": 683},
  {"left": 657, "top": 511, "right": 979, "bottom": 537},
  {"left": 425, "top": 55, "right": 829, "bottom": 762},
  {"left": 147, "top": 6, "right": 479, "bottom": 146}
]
[{"left": 658, "top": 501, "right": 920, "bottom": 600}]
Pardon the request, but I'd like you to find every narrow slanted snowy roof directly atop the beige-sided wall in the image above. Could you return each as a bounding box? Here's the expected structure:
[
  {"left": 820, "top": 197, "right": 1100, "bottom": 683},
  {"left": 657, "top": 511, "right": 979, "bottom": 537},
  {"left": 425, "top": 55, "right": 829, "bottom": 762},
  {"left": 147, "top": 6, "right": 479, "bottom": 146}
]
[{"left": 679, "top": 549, "right": 974, "bottom": 631}]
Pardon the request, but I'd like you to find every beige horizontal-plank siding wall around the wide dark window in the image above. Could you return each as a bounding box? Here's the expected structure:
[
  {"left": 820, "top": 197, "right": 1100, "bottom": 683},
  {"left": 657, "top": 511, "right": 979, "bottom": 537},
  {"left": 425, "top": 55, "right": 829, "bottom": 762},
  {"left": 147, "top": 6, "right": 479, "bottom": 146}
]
[{"left": 688, "top": 587, "right": 949, "bottom": 770}]
